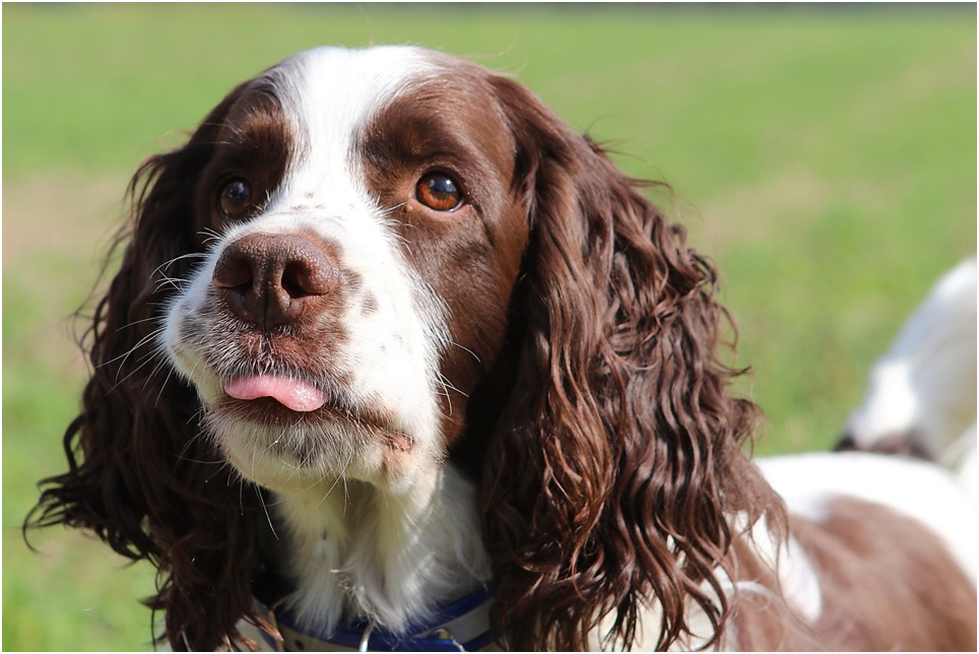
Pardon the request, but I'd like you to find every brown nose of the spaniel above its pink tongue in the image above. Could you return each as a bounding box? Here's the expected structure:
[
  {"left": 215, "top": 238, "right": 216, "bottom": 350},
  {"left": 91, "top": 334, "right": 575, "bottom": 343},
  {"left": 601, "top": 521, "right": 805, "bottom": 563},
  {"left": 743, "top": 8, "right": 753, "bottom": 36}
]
[{"left": 211, "top": 234, "right": 338, "bottom": 330}]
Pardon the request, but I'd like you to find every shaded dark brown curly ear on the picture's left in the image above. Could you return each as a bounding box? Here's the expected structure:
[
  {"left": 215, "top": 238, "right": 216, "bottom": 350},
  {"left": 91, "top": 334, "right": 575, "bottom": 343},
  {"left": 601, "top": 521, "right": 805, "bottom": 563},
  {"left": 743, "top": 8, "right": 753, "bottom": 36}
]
[{"left": 25, "top": 84, "right": 259, "bottom": 650}]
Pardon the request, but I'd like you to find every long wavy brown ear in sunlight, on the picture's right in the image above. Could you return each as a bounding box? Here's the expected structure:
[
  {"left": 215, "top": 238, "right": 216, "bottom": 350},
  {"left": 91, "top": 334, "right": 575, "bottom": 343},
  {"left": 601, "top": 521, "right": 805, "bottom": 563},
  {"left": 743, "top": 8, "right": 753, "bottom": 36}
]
[{"left": 482, "top": 79, "right": 771, "bottom": 651}]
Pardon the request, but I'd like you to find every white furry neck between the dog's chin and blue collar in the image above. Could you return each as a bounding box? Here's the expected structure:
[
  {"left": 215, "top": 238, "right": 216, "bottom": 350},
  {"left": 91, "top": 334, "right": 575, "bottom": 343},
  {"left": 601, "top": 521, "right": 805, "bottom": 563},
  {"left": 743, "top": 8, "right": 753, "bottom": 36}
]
[{"left": 275, "top": 465, "right": 490, "bottom": 633}]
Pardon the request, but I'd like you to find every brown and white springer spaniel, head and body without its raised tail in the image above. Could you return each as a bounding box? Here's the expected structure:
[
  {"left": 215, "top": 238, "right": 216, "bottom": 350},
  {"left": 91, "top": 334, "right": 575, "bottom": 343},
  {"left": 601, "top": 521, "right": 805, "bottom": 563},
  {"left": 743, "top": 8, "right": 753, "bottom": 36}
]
[{"left": 29, "top": 47, "right": 976, "bottom": 651}]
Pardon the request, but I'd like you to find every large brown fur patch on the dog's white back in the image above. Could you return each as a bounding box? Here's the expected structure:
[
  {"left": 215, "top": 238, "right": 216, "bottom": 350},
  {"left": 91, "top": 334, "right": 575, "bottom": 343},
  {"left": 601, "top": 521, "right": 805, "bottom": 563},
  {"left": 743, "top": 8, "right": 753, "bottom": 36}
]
[{"left": 731, "top": 498, "right": 976, "bottom": 652}]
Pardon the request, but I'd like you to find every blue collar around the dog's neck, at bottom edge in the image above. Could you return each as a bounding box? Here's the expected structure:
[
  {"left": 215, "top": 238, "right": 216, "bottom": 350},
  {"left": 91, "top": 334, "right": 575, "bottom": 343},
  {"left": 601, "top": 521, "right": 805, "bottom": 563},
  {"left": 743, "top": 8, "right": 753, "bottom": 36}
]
[{"left": 271, "top": 586, "right": 493, "bottom": 652}]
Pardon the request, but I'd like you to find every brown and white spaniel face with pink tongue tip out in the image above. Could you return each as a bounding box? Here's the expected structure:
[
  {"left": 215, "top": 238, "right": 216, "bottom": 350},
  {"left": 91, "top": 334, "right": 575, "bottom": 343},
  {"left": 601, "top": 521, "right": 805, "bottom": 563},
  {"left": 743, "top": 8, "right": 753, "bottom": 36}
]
[{"left": 161, "top": 48, "right": 529, "bottom": 489}]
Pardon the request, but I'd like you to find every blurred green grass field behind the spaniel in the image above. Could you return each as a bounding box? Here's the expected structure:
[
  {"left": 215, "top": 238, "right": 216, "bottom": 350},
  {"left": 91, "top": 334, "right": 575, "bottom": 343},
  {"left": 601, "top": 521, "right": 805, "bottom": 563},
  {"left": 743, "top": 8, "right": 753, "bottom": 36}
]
[{"left": 2, "top": 3, "right": 977, "bottom": 651}]
